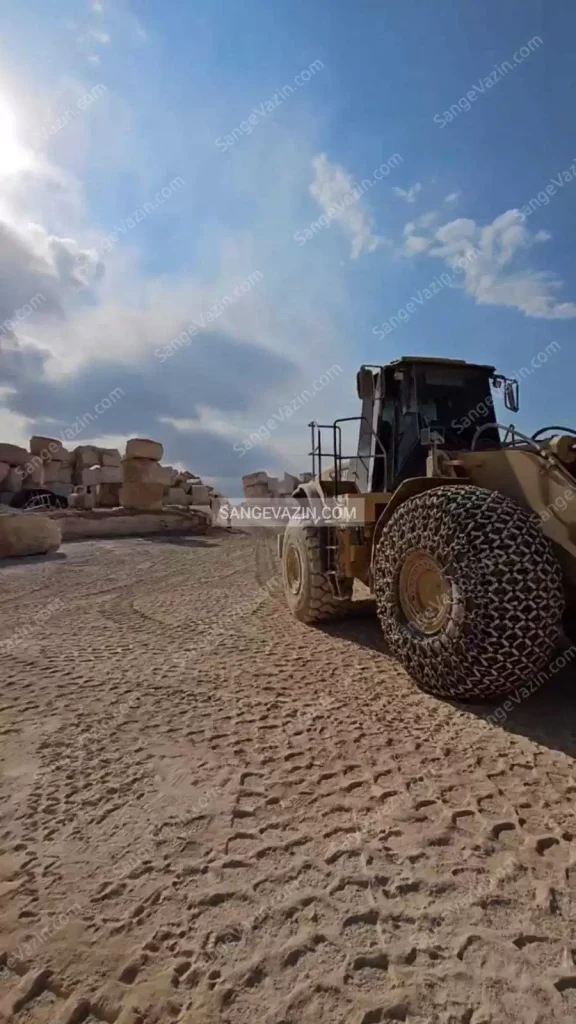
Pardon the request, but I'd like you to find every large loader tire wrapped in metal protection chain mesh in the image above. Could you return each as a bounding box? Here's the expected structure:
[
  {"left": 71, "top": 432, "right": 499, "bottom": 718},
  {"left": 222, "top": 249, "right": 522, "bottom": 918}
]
[{"left": 373, "top": 485, "right": 564, "bottom": 700}]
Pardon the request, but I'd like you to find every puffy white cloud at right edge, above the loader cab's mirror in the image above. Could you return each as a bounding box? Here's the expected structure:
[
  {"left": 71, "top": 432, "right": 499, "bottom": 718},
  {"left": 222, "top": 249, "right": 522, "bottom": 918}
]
[{"left": 428, "top": 210, "right": 576, "bottom": 319}]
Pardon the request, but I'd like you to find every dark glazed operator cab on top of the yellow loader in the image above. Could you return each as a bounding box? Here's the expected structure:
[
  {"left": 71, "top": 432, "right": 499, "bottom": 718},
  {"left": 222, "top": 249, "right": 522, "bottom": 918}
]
[{"left": 355, "top": 356, "right": 510, "bottom": 492}]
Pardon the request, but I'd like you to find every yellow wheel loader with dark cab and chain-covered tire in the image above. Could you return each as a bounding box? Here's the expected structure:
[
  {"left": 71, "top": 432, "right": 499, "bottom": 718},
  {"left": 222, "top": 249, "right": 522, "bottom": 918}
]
[{"left": 279, "top": 356, "right": 576, "bottom": 701}]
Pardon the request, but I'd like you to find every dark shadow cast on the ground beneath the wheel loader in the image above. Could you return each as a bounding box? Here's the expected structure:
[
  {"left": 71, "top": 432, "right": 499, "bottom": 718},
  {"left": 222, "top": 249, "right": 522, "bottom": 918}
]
[{"left": 318, "top": 600, "right": 576, "bottom": 759}]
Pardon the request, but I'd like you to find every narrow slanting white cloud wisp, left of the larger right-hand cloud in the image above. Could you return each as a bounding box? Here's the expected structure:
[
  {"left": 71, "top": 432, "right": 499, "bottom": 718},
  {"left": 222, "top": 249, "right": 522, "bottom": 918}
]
[{"left": 310, "top": 153, "right": 386, "bottom": 259}]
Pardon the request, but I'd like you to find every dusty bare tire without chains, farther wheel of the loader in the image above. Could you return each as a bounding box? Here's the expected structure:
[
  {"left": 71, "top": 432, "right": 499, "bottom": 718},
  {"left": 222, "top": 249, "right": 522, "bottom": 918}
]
[{"left": 282, "top": 525, "right": 354, "bottom": 623}]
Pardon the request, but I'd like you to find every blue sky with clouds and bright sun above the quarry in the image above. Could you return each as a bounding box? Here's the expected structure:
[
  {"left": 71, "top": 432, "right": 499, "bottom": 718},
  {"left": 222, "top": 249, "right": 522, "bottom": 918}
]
[{"left": 0, "top": 0, "right": 576, "bottom": 494}]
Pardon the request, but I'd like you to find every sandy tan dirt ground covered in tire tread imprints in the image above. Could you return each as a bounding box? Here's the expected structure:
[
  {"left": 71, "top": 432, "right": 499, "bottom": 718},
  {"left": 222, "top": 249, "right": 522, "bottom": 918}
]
[{"left": 0, "top": 531, "right": 576, "bottom": 1024}]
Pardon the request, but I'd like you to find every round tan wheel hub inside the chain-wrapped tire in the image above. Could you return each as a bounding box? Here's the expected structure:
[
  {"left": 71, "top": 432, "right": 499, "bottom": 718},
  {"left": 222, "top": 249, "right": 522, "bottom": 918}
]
[{"left": 399, "top": 550, "right": 452, "bottom": 636}]
